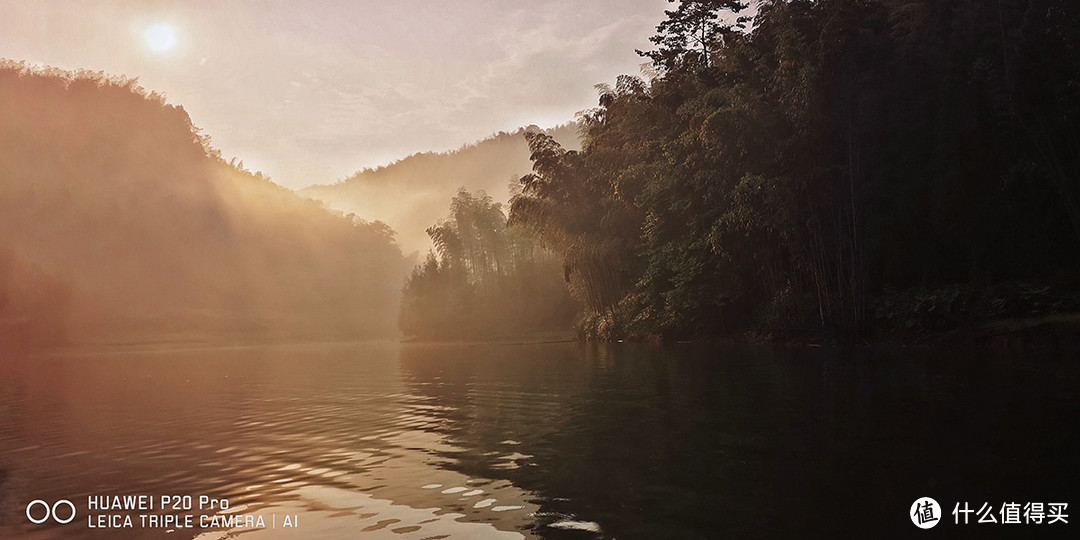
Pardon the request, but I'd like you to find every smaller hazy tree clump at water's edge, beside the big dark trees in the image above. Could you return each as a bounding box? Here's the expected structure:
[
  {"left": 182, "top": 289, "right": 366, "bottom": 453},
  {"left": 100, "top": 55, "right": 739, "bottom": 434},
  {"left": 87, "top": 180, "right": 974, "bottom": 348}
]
[{"left": 400, "top": 188, "right": 579, "bottom": 339}]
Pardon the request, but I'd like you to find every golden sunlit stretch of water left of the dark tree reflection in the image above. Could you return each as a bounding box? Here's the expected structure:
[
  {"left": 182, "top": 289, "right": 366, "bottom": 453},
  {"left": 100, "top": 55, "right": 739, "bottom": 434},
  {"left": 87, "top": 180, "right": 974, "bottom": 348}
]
[{"left": 0, "top": 343, "right": 557, "bottom": 539}]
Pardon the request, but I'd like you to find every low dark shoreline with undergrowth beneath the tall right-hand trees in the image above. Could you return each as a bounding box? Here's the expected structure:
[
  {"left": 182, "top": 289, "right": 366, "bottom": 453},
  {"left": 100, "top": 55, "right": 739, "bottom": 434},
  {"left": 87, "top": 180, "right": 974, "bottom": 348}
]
[{"left": 577, "top": 282, "right": 1080, "bottom": 350}]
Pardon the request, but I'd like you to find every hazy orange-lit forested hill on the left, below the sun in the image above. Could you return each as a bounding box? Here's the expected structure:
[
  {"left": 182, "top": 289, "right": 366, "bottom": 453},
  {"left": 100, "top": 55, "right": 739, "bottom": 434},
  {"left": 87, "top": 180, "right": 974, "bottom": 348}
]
[{"left": 0, "top": 62, "right": 407, "bottom": 349}]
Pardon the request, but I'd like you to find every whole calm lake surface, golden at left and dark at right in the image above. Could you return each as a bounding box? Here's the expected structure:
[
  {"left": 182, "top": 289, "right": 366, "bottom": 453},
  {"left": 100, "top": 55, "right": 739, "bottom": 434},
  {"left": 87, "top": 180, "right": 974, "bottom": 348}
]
[{"left": 0, "top": 343, "right": 1080, "bottom": 539}]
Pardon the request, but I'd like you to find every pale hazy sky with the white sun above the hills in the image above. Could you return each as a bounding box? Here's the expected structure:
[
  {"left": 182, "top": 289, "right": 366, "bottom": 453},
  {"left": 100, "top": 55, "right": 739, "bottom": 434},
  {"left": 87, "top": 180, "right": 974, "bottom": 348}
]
[{"left": 0, "top": 0, "right": 671, "bottom": 188}]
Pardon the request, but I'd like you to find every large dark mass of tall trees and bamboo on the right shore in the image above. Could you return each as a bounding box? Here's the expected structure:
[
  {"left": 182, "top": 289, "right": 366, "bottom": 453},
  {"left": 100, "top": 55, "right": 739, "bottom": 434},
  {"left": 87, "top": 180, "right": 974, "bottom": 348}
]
[{"left": 510, "top": 0, "right": 1080, "bottom": 339}]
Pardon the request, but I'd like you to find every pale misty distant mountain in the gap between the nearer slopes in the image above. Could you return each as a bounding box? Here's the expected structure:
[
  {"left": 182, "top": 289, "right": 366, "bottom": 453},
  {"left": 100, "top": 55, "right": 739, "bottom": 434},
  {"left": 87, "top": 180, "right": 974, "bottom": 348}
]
[{"left": 300, "top": 123, "right": 581, "bottom": 253}]
